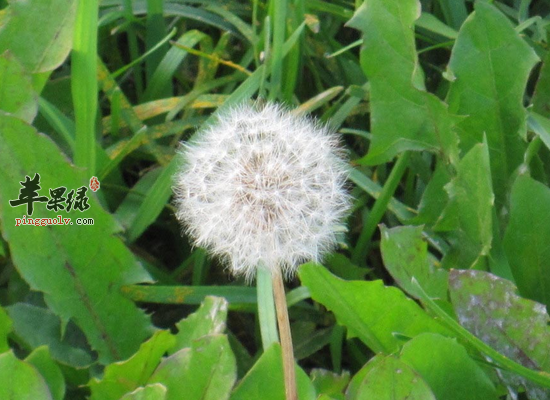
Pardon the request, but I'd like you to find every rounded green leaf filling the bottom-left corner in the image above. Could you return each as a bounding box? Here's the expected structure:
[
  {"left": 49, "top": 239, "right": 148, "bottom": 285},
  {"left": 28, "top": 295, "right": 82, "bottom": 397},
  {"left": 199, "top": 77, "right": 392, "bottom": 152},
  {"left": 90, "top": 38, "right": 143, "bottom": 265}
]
[{"left": 0, "top": 351, "right": 52, "bottom": 400}]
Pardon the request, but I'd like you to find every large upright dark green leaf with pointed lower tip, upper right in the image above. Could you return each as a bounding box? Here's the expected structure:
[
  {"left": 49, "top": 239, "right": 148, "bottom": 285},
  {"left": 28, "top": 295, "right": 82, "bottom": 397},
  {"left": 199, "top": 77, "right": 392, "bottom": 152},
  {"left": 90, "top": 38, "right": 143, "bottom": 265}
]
[{"left": 447, "top": 2, "right": 538, "bottom": 205}]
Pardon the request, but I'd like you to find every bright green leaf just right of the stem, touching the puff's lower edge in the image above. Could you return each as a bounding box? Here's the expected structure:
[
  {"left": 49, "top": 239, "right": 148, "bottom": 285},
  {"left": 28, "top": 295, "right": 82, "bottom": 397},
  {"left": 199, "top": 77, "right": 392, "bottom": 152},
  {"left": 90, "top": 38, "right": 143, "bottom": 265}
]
[{"left": 299, "top": 263, "right": 447, "bottom": 354}]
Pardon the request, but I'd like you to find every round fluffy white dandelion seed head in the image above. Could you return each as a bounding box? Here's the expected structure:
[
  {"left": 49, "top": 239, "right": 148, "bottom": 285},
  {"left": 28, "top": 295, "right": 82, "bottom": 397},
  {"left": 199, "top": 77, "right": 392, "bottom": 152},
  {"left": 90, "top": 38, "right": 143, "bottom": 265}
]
[{"left": 174, "top": 103, "right": 350, "bottom": 278}]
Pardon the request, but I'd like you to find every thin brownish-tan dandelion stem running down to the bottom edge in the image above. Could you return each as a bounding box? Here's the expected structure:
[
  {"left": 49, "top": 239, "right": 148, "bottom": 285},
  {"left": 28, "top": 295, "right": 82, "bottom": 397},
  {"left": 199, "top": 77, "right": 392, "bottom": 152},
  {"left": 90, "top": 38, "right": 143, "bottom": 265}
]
[{"left": 273, "top": 271, "right": 298, "bottom": 400}]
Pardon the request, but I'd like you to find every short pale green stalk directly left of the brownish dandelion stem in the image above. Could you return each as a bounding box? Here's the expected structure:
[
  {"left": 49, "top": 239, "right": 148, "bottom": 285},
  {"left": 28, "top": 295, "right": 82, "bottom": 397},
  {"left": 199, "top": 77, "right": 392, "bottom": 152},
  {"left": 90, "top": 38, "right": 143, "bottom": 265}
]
[{"left": 256, "top": 266, "right": 279, "bottom": 350}]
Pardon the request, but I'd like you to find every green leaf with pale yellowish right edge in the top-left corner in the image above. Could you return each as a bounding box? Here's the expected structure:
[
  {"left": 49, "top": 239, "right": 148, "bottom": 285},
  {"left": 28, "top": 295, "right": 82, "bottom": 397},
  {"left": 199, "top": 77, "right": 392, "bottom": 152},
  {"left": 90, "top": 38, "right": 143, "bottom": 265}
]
[{"left": 0, "top": 0, "right": 77, "bottom": 73}]
